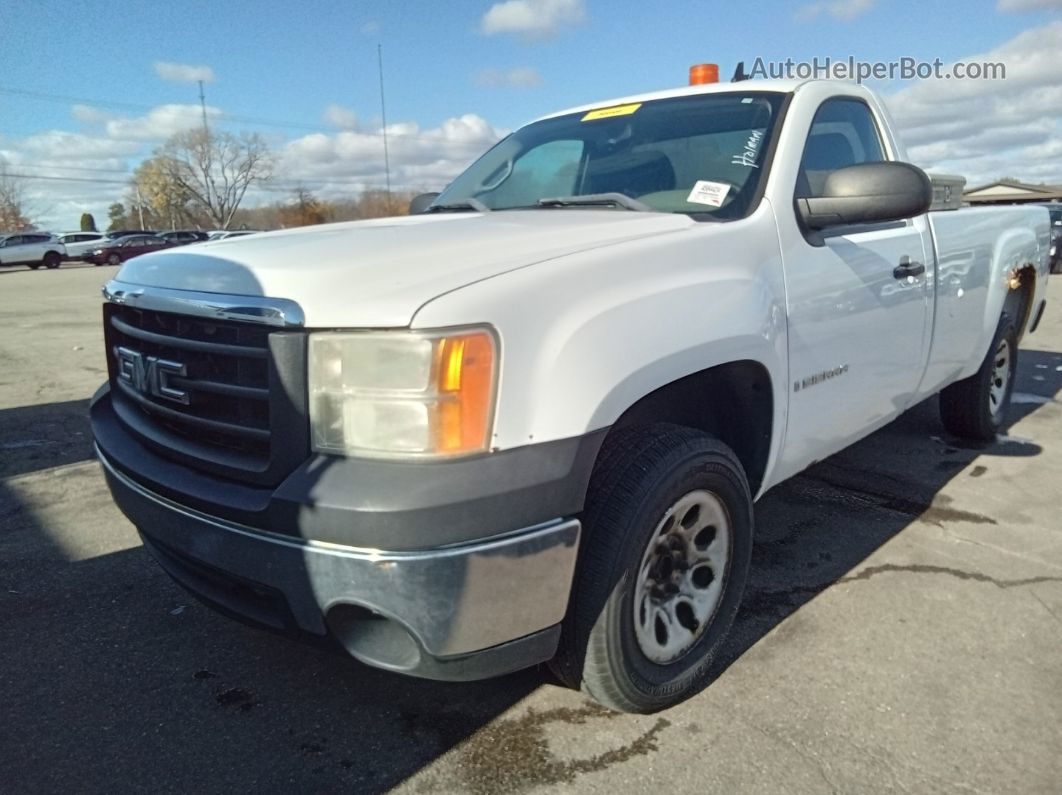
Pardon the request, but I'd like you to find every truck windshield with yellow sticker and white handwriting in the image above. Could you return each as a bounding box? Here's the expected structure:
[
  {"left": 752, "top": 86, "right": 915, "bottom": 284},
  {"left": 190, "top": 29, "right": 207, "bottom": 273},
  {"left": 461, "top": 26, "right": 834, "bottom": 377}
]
[{"left": 433, "top": 92, "right": 783, "bottom": 221}]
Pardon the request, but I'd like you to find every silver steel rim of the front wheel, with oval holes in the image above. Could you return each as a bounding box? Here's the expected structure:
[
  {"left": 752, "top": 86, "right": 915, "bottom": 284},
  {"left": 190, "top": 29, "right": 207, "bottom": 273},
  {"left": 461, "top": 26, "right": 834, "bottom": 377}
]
[{"left": 634, "top": 489, "right": 733, "bottom": 666}]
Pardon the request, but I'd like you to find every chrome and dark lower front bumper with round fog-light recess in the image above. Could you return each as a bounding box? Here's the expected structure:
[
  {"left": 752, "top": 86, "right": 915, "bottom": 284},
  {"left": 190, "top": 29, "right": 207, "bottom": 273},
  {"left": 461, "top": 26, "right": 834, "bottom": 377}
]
[{"left": 97, "top": 447, "right": 580, "bottom": 679}]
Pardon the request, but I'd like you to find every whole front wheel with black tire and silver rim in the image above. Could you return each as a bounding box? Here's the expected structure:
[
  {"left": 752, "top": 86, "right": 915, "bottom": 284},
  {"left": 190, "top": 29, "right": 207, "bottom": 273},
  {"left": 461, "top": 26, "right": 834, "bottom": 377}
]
[{"left": 552, "top": 424, "right": 752, "bottom": 712}]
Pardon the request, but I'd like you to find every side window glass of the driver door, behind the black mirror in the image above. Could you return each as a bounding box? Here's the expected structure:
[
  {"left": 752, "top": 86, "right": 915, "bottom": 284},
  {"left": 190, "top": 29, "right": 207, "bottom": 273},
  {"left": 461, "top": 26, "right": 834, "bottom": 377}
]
[{"left": 797, "top": 99, "right": 886, "bottom": 198}]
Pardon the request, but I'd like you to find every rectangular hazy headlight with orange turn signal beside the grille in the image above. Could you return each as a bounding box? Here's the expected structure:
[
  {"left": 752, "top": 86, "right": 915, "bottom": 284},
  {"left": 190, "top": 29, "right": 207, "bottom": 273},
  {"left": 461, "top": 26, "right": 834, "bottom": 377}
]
[{"left": 309, "top": 329, "right": 498, "bottom": 457}]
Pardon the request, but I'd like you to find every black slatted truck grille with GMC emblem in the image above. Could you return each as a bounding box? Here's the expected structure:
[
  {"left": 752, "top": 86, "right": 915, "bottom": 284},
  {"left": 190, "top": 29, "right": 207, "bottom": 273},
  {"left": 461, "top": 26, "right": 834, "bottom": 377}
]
[{"left": 104, "top": 304, "right": 309, "bottom": 485}]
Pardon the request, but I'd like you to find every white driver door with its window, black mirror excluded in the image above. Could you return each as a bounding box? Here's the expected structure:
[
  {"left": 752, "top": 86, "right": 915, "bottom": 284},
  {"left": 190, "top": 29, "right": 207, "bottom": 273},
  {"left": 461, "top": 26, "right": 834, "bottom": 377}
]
[{"left": 784, "top": 98, "right": 931, "bottom": 471}]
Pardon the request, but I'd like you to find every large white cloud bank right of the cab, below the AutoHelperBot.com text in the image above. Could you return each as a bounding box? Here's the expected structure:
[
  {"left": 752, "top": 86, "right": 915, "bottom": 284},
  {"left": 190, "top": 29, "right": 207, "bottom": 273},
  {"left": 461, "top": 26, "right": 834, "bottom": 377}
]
[{"left": 887, "top": 22, "right": 1062, "bottom": 185}]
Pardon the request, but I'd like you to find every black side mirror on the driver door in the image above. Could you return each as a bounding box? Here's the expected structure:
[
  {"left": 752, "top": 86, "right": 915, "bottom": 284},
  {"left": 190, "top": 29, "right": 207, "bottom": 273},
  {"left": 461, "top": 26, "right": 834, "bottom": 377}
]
[{"left": 797, "top": 162, "right": 932, "bottom": 229}]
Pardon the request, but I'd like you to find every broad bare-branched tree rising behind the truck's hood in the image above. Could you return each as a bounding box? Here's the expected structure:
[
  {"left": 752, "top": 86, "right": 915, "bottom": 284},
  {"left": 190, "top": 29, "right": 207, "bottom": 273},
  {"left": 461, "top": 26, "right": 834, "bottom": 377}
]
[{"left": 153, "top": 128, "right": 273, "bottom": 229}]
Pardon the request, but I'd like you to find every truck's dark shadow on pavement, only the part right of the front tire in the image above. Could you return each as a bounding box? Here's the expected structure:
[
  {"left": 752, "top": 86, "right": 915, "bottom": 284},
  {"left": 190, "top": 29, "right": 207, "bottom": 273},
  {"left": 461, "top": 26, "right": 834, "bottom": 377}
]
[{"left": 716, "top": 350, "right": 1062, "bottom": 672}]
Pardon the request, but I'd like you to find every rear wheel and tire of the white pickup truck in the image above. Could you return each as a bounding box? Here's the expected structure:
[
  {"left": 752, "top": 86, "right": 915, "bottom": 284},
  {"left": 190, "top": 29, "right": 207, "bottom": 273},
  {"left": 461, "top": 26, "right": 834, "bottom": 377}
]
[{"left": 940, "top": 314, "right": 1017, "bottom": 442}]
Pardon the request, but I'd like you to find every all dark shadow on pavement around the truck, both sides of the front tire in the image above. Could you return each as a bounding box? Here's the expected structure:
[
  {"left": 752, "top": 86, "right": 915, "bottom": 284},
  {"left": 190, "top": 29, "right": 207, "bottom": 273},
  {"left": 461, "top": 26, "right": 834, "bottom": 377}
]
[{"left": 0, "top": 351, "right": 1062, "bottom": 792}]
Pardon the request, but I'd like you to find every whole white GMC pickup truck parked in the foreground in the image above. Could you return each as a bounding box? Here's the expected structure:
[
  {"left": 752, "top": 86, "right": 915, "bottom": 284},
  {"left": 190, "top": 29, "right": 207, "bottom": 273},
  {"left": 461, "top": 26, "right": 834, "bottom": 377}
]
[{"left": 91, "top": 75, "right": 1049, "bottom": 711}]
